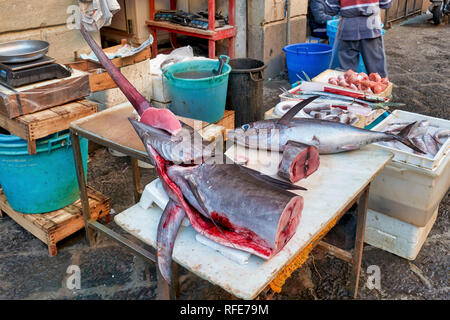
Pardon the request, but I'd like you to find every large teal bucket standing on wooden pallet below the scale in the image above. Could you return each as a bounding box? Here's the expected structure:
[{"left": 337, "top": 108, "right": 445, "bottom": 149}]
[{"left": 0, "top": 131, "right": 88, "bottom": 214}]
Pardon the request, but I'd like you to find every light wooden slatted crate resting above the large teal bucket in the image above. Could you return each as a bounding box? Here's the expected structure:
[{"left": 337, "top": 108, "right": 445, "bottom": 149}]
[{"left": 0, "top": 99, "right": 97, "bottom": 154}]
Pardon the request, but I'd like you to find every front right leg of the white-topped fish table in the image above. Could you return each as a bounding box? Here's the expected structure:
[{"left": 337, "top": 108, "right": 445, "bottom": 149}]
[{"left": 348, "top": 184, "right": 370, "bottom": 299}]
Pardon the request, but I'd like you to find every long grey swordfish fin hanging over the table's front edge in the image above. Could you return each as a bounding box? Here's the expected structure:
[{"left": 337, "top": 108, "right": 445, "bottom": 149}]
[{"left": 156, "top": 200, "right": 186, "bottom": 285}]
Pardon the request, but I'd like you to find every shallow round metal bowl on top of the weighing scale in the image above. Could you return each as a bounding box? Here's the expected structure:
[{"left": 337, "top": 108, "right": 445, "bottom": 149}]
[{"left": 0, "top": 40, "right": 50, "bottom": 63}]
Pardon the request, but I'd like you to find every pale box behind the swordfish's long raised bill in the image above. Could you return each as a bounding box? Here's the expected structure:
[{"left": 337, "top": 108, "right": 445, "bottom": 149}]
[{"left": 89, "top": 60, "right": 153, "bottom": 108}]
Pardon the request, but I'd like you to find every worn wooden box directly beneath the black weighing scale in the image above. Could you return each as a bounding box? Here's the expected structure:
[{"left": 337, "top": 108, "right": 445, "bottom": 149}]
[{"left": 0, "top": 70, "right": 90, "bottom": 119}]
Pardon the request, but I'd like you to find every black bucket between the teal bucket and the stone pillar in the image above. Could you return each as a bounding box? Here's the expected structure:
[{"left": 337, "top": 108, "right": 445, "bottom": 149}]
[{"left": 226, "top": 58, "right": 267, "bottom": 127}]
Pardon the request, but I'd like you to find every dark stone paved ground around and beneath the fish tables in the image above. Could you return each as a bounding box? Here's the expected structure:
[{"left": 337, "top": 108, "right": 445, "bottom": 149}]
[{"left": 0, "top": 13, "right": 450, "bottom": 299}]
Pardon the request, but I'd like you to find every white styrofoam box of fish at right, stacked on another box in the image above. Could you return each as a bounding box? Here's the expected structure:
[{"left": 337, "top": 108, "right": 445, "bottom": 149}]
[{"left": 369, "top": 110, "right": 450, "bottom": 227}]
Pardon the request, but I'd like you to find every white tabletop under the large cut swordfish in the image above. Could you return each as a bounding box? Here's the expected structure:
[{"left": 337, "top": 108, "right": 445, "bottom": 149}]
[{"left": 114, "top": 146, "right": 392, "bottom": 299}]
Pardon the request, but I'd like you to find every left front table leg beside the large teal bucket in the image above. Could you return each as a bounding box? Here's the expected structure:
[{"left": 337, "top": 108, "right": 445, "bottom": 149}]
[{"left": 70, "top": 130, "right": 95, "bottom": 246}]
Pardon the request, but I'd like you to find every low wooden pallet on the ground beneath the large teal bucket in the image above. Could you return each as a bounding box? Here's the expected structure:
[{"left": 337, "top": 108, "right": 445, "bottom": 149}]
[{"left": 0, "top": 187, "right": 111, "bottom": 256}]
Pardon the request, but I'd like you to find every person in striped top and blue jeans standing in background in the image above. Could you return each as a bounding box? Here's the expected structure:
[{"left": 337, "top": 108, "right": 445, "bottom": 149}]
[{"left": 325, "top": 0, "right": 393, "bottom": 78}]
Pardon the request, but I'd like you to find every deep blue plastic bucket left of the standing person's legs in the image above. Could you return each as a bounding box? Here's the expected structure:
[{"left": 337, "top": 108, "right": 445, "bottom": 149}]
[{"left": 283, "top": 43, "right": 332, "bottom": 83}]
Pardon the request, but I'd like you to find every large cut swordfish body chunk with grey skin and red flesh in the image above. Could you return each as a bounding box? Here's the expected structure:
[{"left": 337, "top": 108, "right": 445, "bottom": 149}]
[{"left": 167, "top": 163, "right": 303, "bottom": 259}]
